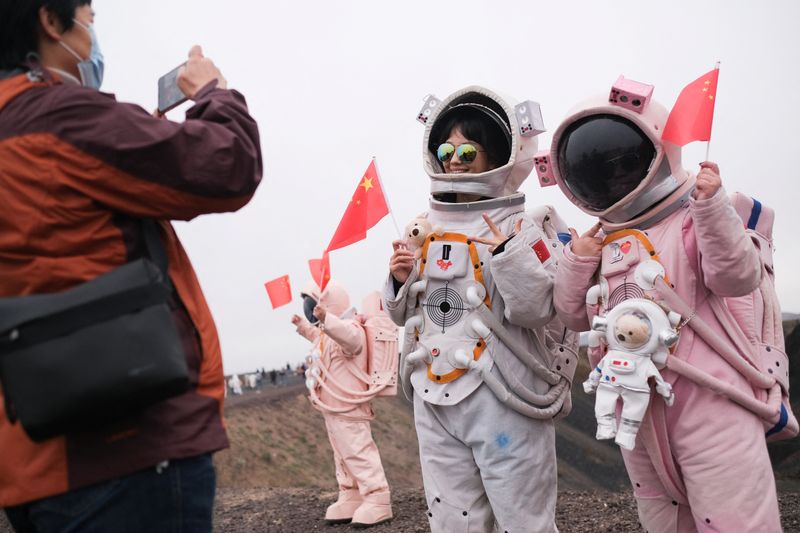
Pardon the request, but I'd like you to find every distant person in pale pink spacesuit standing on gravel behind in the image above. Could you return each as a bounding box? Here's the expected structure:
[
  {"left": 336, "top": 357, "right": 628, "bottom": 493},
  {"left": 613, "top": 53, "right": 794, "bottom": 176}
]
[{"left": 292, "top": 280, "right": 392, "bottom": 526}]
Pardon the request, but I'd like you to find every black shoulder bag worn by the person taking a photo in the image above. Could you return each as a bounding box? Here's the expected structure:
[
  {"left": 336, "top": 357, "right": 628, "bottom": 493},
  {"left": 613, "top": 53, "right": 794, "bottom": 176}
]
[{"left": 0, "top": 220, "right": 189, "bottom": 441}]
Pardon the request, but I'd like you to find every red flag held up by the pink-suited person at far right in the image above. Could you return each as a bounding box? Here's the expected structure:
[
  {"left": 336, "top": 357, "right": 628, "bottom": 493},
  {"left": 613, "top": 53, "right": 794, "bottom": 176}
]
[{"left": 661, "top": 68, "right": 719, "bottom": 146}]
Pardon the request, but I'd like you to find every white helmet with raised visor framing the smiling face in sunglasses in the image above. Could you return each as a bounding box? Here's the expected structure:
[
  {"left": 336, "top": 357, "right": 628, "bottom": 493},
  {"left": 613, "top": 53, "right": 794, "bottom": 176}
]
[{"left": 417, "top": 86, "right": 544, "bottom": 198}]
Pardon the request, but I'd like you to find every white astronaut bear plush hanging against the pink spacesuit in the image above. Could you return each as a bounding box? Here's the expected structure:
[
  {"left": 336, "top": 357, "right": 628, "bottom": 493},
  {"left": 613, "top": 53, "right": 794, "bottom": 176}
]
[{"left": 583, "top": 298, "right": 680, "bottom": 450}]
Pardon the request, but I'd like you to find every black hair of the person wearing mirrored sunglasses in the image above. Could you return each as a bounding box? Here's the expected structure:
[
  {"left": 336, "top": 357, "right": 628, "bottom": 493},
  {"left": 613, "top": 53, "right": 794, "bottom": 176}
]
[{"left": 428, "top": 106, "right": 511, "bottom": 168}]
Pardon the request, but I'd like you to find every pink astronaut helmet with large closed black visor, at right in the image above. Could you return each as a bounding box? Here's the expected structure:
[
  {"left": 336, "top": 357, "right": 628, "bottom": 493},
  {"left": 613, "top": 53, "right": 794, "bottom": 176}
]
[{"left": 536, "top": 76, "right": 693, "bottom": 231}]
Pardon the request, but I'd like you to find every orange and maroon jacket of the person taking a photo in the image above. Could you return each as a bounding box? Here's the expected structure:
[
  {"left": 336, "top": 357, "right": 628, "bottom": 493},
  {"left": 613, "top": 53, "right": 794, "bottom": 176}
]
[{"left": 0, "top": 68, "right": 261, "bottom": 507}]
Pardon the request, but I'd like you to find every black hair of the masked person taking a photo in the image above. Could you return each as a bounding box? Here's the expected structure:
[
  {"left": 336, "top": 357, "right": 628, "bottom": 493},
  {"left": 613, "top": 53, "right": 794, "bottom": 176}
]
[{"left": 0, "top": 0, "right": 92, "bottom": 70}]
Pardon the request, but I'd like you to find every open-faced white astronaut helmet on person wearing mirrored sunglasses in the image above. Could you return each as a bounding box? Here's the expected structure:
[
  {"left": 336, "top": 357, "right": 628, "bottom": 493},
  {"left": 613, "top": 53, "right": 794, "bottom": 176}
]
[{"left": 417, "top": 86, "right": 544, "bottom": 201}]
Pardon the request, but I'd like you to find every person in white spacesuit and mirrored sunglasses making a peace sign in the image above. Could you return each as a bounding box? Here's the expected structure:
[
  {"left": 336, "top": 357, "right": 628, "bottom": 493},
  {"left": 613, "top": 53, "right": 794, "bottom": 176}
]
[{"left": 384, "top": 87, "right": 576, "bottom": 533}]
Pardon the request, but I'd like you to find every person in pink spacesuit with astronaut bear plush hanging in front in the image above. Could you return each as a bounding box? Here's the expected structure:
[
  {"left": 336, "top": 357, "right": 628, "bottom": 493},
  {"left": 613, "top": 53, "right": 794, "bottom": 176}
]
[{"left": 537, "top": 78, "right": 781, "bottom": 533}]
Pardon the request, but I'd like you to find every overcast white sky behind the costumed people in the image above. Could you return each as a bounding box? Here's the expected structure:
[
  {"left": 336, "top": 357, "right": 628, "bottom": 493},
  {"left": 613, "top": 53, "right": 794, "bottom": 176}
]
[{"left": 98, "top": 0, "right": 800, "bottom": 373}]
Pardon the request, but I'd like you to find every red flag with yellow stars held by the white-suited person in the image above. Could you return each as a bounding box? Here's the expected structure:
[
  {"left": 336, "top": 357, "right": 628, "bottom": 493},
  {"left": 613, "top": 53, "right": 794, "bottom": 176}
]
[{"left": 328, "top": 161, "right": 389, "bottom": 251}]
